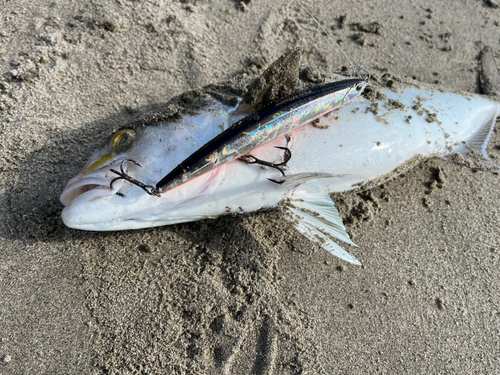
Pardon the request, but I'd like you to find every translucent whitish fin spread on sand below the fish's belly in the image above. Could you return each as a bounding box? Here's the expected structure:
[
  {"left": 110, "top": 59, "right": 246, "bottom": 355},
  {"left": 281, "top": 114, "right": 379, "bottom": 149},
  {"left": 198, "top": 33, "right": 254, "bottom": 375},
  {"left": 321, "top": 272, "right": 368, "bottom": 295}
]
[{"left": 281, "top": 192, "right": 361, "bottom": 266}]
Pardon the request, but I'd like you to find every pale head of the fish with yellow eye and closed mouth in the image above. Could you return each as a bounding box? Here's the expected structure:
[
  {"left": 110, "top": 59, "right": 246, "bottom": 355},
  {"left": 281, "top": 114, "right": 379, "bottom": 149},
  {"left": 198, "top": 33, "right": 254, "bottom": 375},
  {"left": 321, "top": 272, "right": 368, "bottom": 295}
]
[{"left": 60, "top": 104, "right": 229, "bottom": 231}]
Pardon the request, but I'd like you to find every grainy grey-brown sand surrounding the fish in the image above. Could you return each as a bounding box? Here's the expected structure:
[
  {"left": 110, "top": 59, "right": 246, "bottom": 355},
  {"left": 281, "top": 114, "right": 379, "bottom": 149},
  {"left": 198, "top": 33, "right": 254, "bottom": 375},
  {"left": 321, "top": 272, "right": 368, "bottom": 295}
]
[{"left": 0, "top": 0, "right": 500, "bottom": 374}]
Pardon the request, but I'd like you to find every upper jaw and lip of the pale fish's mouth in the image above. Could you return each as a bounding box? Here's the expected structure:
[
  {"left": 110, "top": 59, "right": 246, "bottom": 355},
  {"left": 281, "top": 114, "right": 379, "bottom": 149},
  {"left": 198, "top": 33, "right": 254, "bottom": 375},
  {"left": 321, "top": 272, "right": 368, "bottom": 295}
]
[{"left": 59, "top": 169, "right": 123, "bottom": 206}]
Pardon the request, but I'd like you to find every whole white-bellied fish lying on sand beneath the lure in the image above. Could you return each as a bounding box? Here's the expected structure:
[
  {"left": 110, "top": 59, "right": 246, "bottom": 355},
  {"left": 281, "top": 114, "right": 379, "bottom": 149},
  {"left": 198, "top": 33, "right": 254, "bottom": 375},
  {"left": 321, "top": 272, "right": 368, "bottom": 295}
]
[{"left": 60, "top": 53, "right": 500, "bottom": 265}]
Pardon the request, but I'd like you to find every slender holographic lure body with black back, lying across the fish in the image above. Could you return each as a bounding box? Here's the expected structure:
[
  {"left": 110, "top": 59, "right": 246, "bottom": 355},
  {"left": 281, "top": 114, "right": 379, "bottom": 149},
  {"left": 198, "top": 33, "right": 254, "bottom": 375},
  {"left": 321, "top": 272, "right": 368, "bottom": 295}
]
[{"left": 156, "top": 78, "right": 368, "bottom": 193}]
